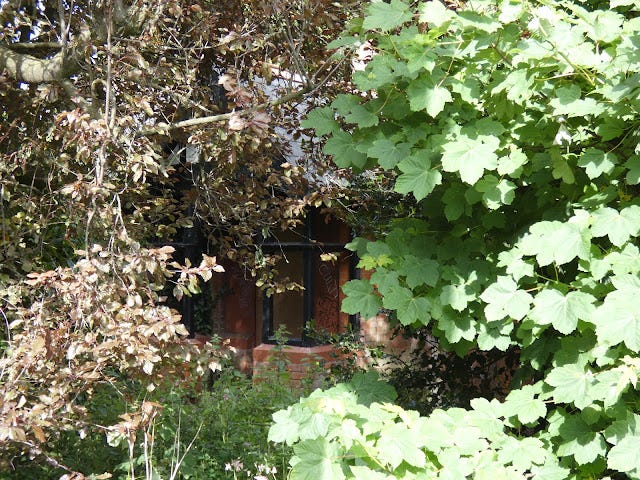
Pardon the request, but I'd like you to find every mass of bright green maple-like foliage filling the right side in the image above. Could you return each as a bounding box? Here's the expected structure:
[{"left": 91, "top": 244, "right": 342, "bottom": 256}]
[{"left": 271, "top": 0, "right": 640, "bottom": 480}]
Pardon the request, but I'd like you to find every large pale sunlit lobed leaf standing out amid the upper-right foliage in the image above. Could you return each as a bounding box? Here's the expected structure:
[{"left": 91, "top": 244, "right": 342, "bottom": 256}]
[{"left": 442, "top": 134, "right": 500, "bottom": 185}]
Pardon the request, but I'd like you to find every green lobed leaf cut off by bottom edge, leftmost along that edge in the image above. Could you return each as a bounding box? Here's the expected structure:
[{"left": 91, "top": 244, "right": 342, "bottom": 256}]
[{"left": 289, "top": 438, "right": 345, "bottom": 480}]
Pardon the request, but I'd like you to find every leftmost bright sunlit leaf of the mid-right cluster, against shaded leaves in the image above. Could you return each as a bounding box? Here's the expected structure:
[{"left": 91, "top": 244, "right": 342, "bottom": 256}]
[{"left": 480, "top": 277, "right": 532, "bottom": 321}]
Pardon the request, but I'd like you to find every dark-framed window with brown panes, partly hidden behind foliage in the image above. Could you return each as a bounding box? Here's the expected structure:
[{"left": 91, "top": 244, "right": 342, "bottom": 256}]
[{"left": 262, "top": 210, "right": 354, "bottom": 346}]
